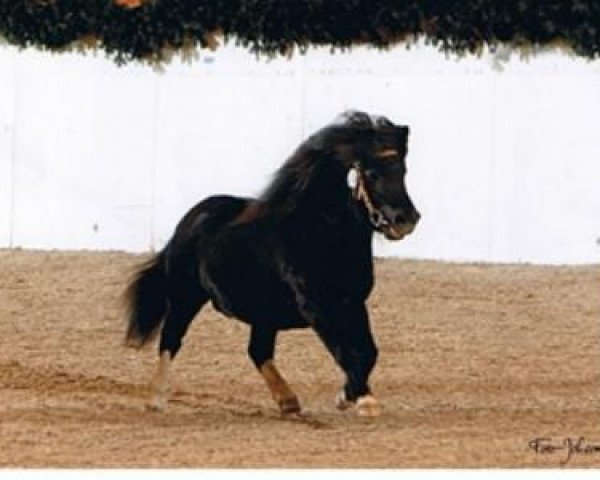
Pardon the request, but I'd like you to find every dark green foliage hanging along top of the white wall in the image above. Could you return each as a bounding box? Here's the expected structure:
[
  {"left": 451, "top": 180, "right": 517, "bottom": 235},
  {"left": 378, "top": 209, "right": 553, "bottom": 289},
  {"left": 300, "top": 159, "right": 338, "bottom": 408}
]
[{"left": 0, "top": 0, "right": 600, "bottom": 63}]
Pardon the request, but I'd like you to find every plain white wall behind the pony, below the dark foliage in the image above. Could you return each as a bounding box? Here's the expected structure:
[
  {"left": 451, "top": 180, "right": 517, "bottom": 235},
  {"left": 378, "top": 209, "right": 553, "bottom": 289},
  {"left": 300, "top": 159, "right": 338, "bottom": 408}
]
[{"left": 0, "top": 46, "right": 600, "bottom": 263}]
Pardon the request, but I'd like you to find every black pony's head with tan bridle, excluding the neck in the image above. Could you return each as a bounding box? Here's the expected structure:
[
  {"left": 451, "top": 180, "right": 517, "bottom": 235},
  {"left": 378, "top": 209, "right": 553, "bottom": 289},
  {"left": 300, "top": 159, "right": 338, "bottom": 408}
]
[{"left": 327, "top": 111, "right": 421, "bottom": 240}]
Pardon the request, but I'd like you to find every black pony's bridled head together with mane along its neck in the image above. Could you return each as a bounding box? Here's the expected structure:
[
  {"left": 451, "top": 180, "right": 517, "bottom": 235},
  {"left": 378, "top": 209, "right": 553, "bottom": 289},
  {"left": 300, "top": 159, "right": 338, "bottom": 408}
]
[{"left": 261, "top": 111, "right": 420, "bottom": 240}]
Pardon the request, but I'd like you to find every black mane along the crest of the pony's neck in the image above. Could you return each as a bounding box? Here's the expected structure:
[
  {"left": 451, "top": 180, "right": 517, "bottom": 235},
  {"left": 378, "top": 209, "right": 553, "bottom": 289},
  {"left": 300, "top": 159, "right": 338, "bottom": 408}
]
[{"left": 259, "top": 111, "right": 374, "bottom": 214}]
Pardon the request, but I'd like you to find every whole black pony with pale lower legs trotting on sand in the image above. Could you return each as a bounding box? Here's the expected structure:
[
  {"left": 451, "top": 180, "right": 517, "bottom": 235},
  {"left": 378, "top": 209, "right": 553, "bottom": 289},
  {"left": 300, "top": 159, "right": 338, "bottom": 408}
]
[{"left": 126, "top": 112, "right": 420, "bottom": 415}]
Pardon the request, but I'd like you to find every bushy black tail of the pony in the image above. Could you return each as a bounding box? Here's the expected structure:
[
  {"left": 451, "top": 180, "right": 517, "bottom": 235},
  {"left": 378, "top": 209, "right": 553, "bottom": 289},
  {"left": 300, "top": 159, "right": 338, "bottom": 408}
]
[{"left": 124, "top": 249, "right": 167, "bottom": 348}]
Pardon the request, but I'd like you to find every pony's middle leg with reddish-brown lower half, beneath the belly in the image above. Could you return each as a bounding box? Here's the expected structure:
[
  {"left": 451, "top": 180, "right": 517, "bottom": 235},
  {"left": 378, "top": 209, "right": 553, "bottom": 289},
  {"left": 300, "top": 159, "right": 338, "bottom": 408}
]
[{"left": 248, "top": 326, "right": 300, "bottom": 414}]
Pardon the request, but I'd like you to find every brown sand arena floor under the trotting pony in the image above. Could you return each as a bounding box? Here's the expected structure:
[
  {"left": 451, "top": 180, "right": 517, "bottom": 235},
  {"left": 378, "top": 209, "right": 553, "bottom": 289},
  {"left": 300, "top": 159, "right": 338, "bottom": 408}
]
[{"left": 0, "top": 250, "right": 600, "bottom": 467}]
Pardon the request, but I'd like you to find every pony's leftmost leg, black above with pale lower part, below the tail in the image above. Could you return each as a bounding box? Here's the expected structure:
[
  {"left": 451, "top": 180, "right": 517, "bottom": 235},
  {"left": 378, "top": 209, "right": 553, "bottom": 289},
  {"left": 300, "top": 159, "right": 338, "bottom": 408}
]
[{"left": 148, "top": 284, "right": 208, "bottom": 411}]
